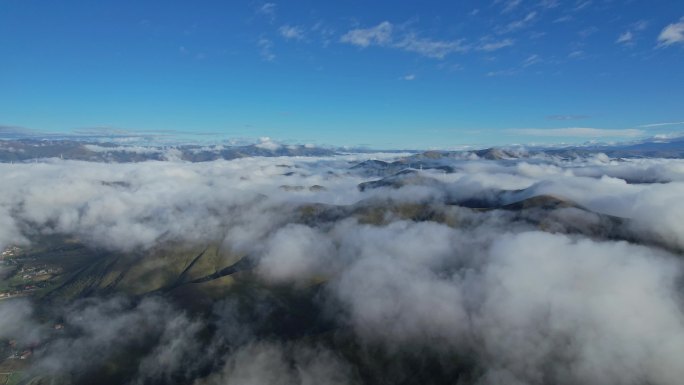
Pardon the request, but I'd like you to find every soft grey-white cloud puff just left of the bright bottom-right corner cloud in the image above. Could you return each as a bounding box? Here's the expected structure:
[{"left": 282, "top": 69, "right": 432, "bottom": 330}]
[{"left": 334, "top": 222, "right": 466, "bottom": 344}]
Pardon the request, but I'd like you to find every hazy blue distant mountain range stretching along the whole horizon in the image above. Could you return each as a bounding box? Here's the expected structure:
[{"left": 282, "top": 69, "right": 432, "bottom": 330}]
[{"left": 0, "top": 137, "right": 684, "bottom": 162}]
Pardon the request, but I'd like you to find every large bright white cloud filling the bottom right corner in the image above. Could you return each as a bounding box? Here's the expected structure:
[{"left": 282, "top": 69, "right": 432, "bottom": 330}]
[{"left": 478, "top": 233, "right": 683, "bottom": 384}]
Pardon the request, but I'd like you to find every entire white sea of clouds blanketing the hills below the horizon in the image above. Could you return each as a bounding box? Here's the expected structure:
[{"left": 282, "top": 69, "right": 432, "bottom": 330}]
[{"left": 0, "top": 154, "right": 684, "bottom": 385}]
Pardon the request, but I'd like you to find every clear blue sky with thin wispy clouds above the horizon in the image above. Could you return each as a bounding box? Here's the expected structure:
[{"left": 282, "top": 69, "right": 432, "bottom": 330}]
[{"left": 0, "top": 0, "right": 684, "bottom": 148}]
